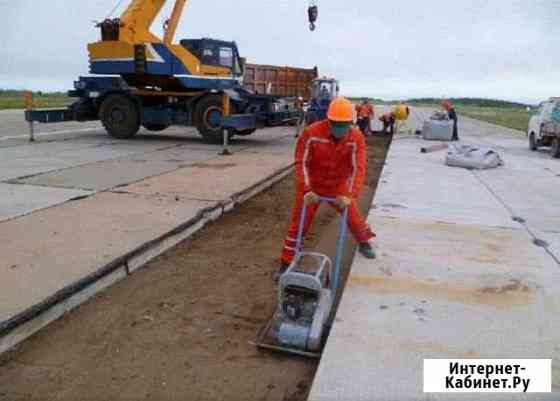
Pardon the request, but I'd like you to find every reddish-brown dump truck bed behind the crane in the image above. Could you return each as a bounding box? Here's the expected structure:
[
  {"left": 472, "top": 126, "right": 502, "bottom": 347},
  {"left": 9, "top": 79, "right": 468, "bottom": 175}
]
[{"left": 243, "top": 64, "right": 319, "bottom": 100}]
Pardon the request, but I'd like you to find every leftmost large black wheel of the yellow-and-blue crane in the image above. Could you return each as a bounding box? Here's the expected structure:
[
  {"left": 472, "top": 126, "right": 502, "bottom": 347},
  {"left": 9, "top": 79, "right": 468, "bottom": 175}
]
[{"left": 99, "top": 94, "right": 140, "bottom": 139}]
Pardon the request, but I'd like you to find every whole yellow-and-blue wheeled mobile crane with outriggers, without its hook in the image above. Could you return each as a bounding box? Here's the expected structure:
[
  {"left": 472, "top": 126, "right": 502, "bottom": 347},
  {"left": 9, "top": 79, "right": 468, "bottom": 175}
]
[{"left": 25, "top": 0, "right": 300, "bottom": 142}]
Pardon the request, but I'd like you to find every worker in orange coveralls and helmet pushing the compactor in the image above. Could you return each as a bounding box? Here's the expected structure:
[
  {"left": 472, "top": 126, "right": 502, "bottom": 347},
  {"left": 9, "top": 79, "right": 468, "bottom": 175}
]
[{"left": 274, "top": 98, "right": 375, "bottom": 280}]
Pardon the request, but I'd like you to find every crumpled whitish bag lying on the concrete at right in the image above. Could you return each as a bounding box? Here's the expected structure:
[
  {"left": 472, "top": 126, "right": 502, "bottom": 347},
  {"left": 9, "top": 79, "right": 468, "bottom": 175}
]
[{"left": 445, "top": 144, "right": 504, "bottom": 170}]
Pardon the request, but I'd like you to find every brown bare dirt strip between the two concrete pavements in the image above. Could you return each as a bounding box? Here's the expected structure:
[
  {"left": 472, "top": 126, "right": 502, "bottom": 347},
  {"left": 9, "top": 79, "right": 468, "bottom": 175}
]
[{"left": 0, "top": 137, "right": 389, "bottom": 401}]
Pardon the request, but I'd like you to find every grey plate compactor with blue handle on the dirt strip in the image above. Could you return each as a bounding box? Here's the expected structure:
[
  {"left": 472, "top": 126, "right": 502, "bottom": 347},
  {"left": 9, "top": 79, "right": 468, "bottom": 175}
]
[{"left": 256, "top": 198, "right": 348, "bottom": 358}]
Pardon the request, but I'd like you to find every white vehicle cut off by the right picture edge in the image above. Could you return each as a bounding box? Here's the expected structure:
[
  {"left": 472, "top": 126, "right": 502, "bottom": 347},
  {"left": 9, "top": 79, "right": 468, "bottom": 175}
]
[{"left": 527, "top": 97, "right": 560, "bottom": 158}]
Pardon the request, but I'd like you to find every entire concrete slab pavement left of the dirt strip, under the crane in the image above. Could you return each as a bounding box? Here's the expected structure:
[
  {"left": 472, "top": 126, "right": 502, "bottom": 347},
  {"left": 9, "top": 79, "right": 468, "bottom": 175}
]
[{"left": 0, "top": 112, "right": 295, "bottom": 352}]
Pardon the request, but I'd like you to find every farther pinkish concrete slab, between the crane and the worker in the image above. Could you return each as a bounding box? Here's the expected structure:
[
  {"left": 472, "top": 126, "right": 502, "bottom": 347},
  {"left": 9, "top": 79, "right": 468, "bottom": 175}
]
[{"left": 119, "top": 151, "right": 293, "bottom": 201}]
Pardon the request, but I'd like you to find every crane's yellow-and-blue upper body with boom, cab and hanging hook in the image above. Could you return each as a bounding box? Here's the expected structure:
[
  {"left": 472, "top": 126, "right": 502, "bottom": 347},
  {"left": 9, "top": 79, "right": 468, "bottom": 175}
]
[{"left": 88, "top": 0, "right": 318, "bottom": 84}]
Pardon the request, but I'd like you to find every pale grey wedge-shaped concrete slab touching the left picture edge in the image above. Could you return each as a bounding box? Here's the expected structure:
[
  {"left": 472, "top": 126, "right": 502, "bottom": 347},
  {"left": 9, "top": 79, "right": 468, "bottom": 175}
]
[{"left": 0, "top": 183, "right": 91, "bottom": 222}]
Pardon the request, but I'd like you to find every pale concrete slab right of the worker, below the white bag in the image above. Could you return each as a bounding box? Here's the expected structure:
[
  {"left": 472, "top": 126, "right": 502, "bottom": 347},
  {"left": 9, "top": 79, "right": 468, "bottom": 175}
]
[{"left": 373, "top": 138, "right": 516, "bottom": 227}]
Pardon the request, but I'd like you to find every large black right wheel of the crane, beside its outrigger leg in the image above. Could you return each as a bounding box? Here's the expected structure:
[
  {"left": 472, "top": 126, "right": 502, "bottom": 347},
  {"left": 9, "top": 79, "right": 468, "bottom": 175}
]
[{"left": 193, "top": 95, "right": 228, "bottom": 143}]
